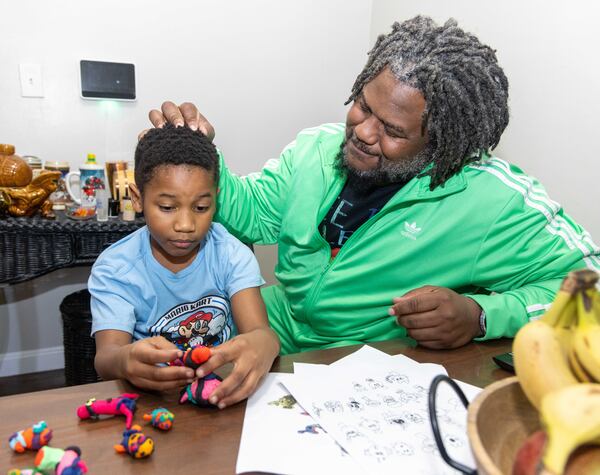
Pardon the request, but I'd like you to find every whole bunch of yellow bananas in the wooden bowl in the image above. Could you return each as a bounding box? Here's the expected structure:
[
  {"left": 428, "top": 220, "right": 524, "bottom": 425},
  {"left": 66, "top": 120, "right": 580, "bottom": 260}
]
[{"left": 513, "top": 270, "right": 600, "bottom": 474}]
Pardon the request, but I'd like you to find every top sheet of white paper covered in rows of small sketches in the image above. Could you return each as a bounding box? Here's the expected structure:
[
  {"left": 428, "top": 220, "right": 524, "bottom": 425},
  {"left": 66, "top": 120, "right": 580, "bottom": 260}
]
[{"left": 284, "top": 347, "right": 480, "bottom": 475}]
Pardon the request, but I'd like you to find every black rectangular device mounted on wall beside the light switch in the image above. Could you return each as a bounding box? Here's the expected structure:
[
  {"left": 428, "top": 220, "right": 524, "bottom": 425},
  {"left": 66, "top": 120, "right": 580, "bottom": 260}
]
[{"left": 79, "top": 59, "right": 135, "bottom": 101}]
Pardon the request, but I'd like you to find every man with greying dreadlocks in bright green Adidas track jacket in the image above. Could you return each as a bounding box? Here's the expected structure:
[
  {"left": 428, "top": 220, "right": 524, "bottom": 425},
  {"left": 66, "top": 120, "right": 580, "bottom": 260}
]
[{"left": 150, "top": 16, "right": 600, "bottom": 353}]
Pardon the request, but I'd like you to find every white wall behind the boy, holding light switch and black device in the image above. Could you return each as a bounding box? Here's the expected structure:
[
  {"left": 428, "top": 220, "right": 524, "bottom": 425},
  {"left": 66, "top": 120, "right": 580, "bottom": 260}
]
[{"left": 0, "top": 0, "right": 371, "bottom": 376}]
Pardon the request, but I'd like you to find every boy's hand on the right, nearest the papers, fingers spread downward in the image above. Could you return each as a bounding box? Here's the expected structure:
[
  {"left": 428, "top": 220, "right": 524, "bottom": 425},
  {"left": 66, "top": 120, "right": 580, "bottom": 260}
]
[{"left": 196, "top": 328, "right": 279, "bottom": 409}]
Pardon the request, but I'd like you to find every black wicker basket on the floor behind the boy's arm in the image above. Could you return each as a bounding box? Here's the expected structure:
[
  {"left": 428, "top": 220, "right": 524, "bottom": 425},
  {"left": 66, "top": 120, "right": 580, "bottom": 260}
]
[{"left": 60, "top": 289, "right": 100, "bottom": 386}]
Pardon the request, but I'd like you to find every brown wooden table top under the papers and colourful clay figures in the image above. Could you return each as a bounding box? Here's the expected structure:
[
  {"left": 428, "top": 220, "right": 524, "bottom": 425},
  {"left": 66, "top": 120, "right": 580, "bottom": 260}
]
[{"left": 0, "top": 340, "right": 512, "bottom": 475}]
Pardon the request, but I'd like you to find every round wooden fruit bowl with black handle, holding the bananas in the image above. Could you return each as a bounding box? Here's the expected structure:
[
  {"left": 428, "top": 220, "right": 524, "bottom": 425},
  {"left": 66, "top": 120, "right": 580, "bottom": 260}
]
[{"left": 467, "top": 376, "right": 540, "bottom": 475}]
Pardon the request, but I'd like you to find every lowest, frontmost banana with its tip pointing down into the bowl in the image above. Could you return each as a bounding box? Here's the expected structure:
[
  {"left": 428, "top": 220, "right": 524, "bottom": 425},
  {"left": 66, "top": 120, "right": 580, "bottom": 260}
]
[{"left": 540, "top": 383, "right": 600, "bottom": 475}]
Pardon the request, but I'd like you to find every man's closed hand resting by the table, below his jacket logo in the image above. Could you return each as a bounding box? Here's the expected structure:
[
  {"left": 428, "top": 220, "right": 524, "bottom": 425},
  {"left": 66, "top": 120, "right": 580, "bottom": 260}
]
[{"left": 389, "top": 285, "right": 481, "bottom": 349}]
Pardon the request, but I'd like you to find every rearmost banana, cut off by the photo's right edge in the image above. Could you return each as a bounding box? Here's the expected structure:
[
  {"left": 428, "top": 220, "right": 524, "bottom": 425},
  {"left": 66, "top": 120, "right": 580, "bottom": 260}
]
[{"left": 573, "top": 288, "right": 600, "bottom": 382}]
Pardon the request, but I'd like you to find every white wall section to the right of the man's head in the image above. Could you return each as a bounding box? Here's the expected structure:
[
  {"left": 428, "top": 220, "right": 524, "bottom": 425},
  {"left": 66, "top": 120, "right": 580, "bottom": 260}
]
[{"left": 371, "top": 0, "right": 600, "bottom": 240}]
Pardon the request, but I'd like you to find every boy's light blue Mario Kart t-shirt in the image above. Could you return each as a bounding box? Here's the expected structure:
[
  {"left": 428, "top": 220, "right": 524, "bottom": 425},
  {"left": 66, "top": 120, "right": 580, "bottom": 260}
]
[{"left": 88, "top": 223, "right": 264, "bottom": 349}]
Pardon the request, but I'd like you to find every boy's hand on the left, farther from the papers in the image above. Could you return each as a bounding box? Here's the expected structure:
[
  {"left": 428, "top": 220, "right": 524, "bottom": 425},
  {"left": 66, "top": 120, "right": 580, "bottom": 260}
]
[{"left": 120, "top": 336, "right": 194, "bottom": 391}]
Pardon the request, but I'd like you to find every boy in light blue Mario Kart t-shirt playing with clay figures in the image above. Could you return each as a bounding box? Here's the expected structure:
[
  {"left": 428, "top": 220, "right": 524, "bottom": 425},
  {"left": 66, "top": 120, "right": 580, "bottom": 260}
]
[{"left": 88, "top": 126, "right": 279, "bottom": 408}]
